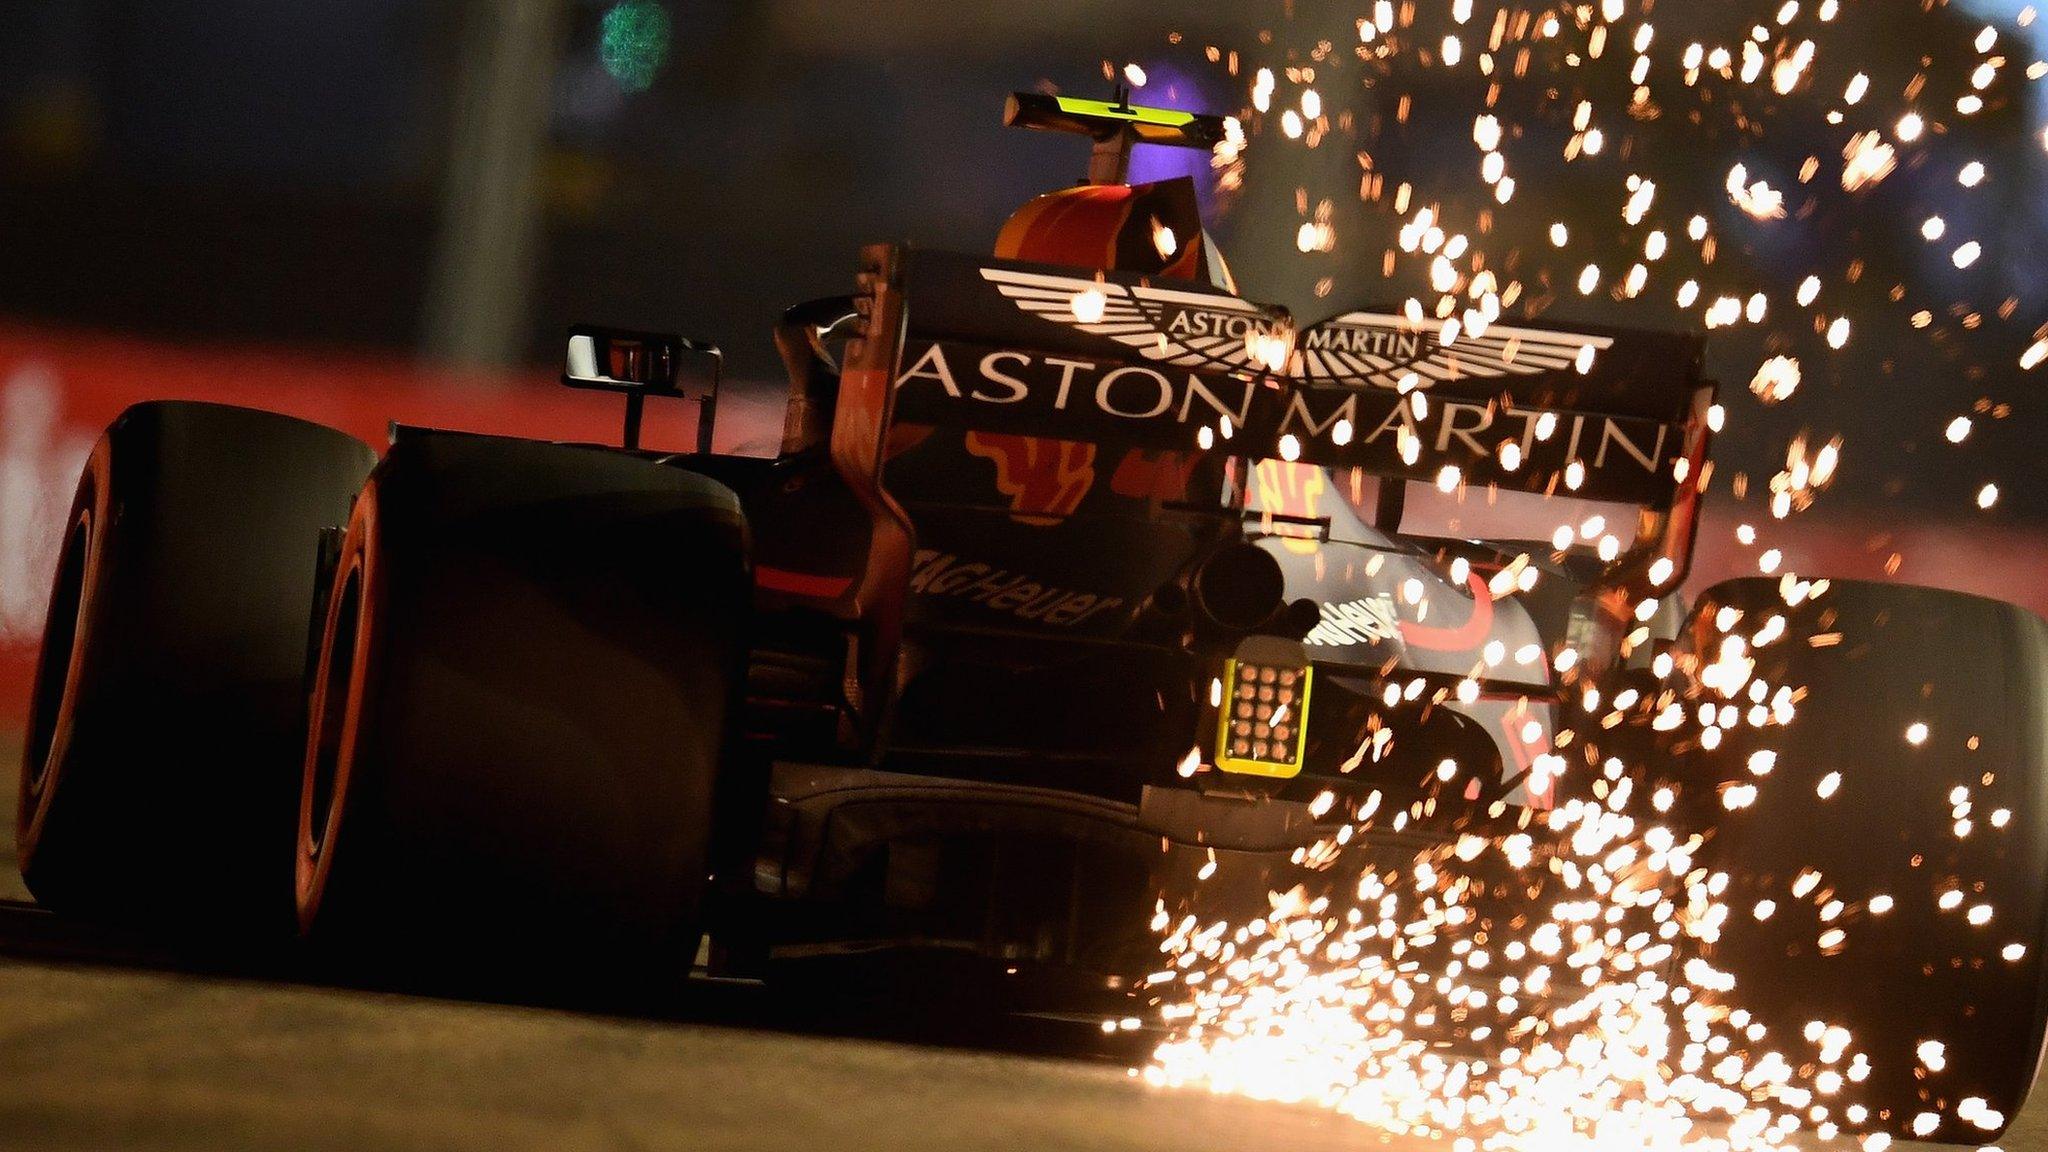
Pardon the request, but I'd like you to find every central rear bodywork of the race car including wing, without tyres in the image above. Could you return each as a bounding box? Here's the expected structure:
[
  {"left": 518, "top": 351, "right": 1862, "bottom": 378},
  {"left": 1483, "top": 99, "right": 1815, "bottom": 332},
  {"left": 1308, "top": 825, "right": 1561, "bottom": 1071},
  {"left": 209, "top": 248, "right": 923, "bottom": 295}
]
[{"left": 655, "top": 248, "right": 1712, "bottom": 984}]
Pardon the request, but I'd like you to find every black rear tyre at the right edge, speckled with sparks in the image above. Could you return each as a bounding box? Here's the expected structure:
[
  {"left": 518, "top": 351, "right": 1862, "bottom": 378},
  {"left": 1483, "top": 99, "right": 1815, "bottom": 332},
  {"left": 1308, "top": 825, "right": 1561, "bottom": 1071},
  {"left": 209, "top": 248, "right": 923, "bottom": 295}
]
[{"left": 1673, "top": 580, "right": 2048, "bottom": 1144}]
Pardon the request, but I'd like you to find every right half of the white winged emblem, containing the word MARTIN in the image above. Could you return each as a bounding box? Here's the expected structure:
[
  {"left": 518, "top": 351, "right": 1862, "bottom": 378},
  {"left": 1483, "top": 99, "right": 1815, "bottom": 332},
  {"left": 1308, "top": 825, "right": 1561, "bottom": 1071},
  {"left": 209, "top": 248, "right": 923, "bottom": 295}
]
[{"left": 1288, "top": 312, "right": 1614, "bottom": 387}]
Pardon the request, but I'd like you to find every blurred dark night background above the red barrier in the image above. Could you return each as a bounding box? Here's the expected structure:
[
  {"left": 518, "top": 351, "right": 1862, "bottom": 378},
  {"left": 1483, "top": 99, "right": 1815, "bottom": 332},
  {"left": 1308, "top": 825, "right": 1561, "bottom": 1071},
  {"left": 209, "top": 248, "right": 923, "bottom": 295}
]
[{"left": 0, "top": 0, "right": 2048, "bottom": 527}]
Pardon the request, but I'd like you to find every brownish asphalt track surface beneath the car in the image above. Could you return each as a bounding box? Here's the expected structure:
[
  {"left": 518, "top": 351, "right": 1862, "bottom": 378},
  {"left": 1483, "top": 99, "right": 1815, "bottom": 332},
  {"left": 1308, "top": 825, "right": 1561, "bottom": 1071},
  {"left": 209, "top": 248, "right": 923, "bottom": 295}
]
[{"left": 0, "top": 734, "right": 2048, "bottom": 1152}]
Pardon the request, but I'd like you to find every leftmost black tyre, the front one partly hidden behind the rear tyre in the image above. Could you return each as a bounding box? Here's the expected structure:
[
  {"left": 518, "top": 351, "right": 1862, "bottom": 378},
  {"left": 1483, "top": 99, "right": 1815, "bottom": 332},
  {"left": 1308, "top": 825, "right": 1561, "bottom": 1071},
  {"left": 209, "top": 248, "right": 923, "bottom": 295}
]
[{"left": 14, "top": 402, "right": 377, "bottom": 933}]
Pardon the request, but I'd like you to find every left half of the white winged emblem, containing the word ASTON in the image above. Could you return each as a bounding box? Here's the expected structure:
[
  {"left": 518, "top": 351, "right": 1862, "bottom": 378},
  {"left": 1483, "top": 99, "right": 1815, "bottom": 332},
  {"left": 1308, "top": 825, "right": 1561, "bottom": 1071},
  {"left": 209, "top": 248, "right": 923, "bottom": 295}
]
[{"left": 981, "top": 269, "right": 1292, "bottom": 371}]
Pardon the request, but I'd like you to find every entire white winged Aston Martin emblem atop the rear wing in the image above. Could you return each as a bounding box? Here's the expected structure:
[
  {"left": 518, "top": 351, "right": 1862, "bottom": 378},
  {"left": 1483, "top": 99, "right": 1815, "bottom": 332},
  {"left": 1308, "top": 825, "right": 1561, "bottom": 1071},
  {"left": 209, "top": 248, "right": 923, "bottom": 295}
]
[{"left": 981, "top": 269, "right": 1614, "bottom": 389}]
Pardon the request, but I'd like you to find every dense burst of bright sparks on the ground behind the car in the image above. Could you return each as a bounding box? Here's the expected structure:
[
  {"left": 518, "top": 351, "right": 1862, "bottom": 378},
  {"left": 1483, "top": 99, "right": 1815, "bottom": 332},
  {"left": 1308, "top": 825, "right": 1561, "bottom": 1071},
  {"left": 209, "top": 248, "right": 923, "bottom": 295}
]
[{"left": 1146, "top": 573, "right": 2025, "bottom": 1152}]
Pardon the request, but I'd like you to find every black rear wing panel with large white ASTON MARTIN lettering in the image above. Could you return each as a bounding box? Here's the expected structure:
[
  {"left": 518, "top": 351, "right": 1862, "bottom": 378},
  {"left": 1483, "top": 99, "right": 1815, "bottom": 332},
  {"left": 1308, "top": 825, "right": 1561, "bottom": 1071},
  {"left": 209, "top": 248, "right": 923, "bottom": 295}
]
[{"left": 893, "top": 252, "right": 1712, "bottom": 510}]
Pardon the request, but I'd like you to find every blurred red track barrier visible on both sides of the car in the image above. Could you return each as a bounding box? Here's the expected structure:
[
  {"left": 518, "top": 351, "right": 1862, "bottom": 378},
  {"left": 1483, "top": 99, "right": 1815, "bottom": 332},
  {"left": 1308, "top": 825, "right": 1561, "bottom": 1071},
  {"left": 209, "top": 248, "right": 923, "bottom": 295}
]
[{"left": 0, "top": 324, "right": 2048, "bottom": 728}]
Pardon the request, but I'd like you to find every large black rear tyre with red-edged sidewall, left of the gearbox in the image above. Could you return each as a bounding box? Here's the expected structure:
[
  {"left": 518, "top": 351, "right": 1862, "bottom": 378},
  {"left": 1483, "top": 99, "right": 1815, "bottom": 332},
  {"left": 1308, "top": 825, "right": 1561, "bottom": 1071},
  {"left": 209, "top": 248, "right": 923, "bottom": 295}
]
[{"left": 295, "top": 433, "right": 752, "bottom": 996}]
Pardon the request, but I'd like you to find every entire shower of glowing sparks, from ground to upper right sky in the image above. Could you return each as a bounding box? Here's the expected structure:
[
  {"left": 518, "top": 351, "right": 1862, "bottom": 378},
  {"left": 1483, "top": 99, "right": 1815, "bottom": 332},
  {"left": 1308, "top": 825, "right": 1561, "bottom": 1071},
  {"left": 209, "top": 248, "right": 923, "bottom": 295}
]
[{"left": 1130, "top": 0, "right": 2048, "bottom": 1152}]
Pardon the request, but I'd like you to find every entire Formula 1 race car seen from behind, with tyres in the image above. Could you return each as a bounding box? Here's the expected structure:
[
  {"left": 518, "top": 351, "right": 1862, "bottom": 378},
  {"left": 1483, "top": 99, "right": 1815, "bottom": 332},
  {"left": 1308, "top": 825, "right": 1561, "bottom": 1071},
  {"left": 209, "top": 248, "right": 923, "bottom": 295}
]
[{"left": 18, "top": 94, "right": 2048, "bottom": 1139}]
